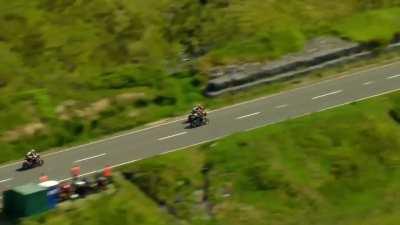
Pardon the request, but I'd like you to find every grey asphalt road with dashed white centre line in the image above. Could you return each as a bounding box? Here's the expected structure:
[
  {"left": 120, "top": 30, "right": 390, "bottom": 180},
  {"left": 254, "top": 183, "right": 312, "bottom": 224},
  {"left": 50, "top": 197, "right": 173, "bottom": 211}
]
[{"left": 0, "top": 62, "right": 400, "bottom": 191}]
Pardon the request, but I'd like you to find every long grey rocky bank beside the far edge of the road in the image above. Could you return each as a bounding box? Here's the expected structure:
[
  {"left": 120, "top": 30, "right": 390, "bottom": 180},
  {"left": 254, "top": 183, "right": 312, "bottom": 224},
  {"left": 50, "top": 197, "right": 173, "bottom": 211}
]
[{"left": 205, "top": 37, "right": 399, "bottom": 96}]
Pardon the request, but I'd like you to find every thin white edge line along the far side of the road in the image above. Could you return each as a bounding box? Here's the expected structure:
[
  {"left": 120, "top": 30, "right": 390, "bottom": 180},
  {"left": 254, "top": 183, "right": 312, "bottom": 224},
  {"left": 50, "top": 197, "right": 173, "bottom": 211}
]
[{"left": 0, "top": 61, "right": 399, "bottom": 169}]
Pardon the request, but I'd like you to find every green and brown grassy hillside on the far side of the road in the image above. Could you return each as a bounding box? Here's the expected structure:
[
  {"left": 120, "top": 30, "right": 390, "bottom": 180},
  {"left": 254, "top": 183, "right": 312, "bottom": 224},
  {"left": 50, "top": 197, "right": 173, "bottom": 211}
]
[{"left": 0, "top": 0, "right": 400, "bottom": 162}]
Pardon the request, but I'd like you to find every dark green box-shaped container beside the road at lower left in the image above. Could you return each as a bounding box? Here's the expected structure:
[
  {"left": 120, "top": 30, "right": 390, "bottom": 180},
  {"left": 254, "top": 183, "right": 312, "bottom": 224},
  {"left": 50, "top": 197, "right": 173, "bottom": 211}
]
[{"left": 3, "top": 184, "right": 49, "bottom": 218}]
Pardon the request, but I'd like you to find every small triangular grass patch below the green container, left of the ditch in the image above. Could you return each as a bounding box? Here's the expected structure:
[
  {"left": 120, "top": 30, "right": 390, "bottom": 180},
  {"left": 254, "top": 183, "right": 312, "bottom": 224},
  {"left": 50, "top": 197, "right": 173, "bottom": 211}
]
[{"left": 18, "top": 175, "right": 174, "bottom": 225}]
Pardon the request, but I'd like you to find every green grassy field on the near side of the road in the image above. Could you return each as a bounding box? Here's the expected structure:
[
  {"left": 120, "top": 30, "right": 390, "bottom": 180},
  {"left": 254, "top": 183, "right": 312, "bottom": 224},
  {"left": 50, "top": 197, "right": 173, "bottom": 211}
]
[{"left": 22, "top": 90, "right": 400, "bottom": 225}]
